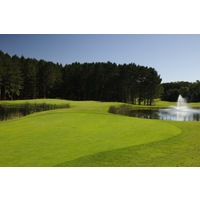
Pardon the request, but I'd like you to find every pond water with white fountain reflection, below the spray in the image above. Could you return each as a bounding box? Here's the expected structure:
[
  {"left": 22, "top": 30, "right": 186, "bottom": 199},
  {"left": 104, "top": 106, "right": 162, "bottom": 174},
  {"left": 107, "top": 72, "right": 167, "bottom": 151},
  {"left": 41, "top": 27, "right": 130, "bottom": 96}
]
[{"left": 128, "top": 108, "right": 200, "bottom": 121}]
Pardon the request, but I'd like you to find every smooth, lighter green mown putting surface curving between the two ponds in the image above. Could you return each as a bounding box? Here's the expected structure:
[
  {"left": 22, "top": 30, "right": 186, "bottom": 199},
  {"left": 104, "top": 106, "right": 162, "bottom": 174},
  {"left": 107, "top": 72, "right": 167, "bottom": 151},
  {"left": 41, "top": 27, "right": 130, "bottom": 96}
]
[{"left": 0, "top": 101, "right": 181, "bottom": 166}]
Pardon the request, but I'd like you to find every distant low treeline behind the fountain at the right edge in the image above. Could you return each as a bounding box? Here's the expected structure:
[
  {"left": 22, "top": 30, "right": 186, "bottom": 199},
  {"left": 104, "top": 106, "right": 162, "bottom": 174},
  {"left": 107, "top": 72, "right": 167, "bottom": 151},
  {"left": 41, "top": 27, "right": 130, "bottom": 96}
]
[{"left": 161, "top": 80, "right": 200, "bottom": 102}]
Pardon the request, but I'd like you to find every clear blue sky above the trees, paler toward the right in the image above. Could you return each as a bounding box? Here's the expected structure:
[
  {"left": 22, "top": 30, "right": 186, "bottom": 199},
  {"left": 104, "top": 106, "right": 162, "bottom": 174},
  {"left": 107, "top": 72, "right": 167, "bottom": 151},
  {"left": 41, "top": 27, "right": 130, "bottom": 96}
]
[{"left": 0, "top": 34, "right": 200, "bottom": 82}]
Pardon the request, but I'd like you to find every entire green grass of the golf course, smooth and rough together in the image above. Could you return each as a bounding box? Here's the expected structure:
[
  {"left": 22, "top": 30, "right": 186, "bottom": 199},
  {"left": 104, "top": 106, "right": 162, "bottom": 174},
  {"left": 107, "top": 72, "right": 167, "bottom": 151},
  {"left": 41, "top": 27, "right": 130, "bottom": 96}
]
[{"left": 0, "top": 99, "right": 200, "bottom": 166}]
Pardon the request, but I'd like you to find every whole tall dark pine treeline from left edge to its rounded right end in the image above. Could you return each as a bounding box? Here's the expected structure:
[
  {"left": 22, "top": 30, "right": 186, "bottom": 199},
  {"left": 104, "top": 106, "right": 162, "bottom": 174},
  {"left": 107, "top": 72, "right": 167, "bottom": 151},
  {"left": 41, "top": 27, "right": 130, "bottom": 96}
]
[{"left": 0, "top": 51, "right": 161, "bottom": 105}]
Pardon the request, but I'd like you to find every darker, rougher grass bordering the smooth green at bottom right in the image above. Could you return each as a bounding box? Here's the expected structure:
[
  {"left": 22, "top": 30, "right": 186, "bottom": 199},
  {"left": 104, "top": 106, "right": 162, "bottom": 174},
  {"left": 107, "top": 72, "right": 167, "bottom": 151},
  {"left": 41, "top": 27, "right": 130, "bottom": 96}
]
[{"left": 57, "top": 122, "right": 200, "bottom": 167}]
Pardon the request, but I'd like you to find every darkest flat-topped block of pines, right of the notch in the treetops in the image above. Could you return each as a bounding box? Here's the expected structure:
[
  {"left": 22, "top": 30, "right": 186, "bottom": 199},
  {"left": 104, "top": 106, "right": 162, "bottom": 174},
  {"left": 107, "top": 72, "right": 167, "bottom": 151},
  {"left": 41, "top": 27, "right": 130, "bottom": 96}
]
[{"left": 64, "top": 62, "right": 161, "bottom": 105}]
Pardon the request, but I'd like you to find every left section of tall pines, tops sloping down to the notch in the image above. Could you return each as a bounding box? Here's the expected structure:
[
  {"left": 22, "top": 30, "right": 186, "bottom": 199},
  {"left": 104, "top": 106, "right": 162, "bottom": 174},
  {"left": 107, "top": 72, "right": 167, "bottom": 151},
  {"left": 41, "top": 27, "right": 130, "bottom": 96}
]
[{"left": 0, "top": 51, "right": 63, "bottom": 99}]
